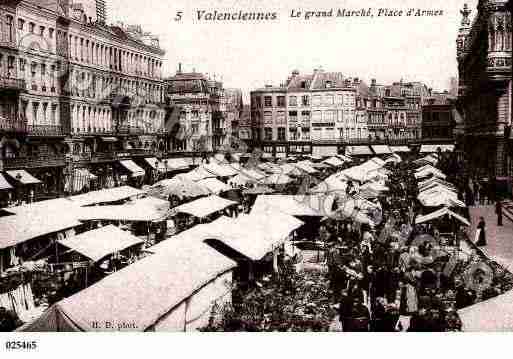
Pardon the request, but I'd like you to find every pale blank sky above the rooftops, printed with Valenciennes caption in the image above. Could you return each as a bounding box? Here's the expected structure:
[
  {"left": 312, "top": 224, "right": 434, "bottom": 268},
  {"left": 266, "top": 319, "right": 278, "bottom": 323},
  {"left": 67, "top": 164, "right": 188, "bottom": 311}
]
[{"left": 107, "top": 0, "right": 477, "bottom": 100}]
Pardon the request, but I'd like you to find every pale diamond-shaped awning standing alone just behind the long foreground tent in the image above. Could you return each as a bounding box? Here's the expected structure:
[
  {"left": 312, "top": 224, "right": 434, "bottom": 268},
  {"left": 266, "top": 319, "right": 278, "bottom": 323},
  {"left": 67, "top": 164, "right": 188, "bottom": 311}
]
[{"left": 59, "top": 225, "right": 144, "bottom": 262}]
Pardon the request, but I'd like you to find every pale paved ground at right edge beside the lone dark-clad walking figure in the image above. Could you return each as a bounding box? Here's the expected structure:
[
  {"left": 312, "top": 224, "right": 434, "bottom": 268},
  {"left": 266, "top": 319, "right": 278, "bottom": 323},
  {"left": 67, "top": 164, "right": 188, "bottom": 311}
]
[{"left": 469, "top": 206, "right": 513, "bottom": 272}]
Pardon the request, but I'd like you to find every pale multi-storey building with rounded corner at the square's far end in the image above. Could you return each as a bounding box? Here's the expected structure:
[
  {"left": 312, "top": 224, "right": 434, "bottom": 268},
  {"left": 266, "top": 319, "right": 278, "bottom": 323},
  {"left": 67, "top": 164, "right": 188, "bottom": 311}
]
[{"left": 251, "top": 69, "right": 370, "bottom": 157}]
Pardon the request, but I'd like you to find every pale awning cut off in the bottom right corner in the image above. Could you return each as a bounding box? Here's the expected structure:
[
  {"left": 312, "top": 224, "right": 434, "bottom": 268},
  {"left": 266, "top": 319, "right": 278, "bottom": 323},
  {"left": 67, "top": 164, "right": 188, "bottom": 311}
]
[{"left": 458, "top": 290, "right": 513, "bottom": 332}]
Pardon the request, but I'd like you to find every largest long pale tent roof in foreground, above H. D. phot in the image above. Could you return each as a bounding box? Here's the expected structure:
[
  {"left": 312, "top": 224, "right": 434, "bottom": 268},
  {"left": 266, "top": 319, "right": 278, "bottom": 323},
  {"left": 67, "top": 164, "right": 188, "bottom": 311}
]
[{"left": 19, "top": 240, "right": 237, "bottom": 332}]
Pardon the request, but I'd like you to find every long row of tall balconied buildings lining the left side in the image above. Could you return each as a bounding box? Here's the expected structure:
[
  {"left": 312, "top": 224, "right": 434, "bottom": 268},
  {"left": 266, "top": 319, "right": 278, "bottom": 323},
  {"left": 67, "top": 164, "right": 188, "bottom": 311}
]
[{"left": 0, "top": 0, "right": 166, "bottom": 200}]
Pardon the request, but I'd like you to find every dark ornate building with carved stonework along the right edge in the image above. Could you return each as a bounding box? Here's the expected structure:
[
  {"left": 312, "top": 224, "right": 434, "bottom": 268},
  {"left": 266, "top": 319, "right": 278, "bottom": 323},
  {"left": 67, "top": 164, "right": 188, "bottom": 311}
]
[{"left": 456, "top": 0, "right": 513, "bottom": 183}]
